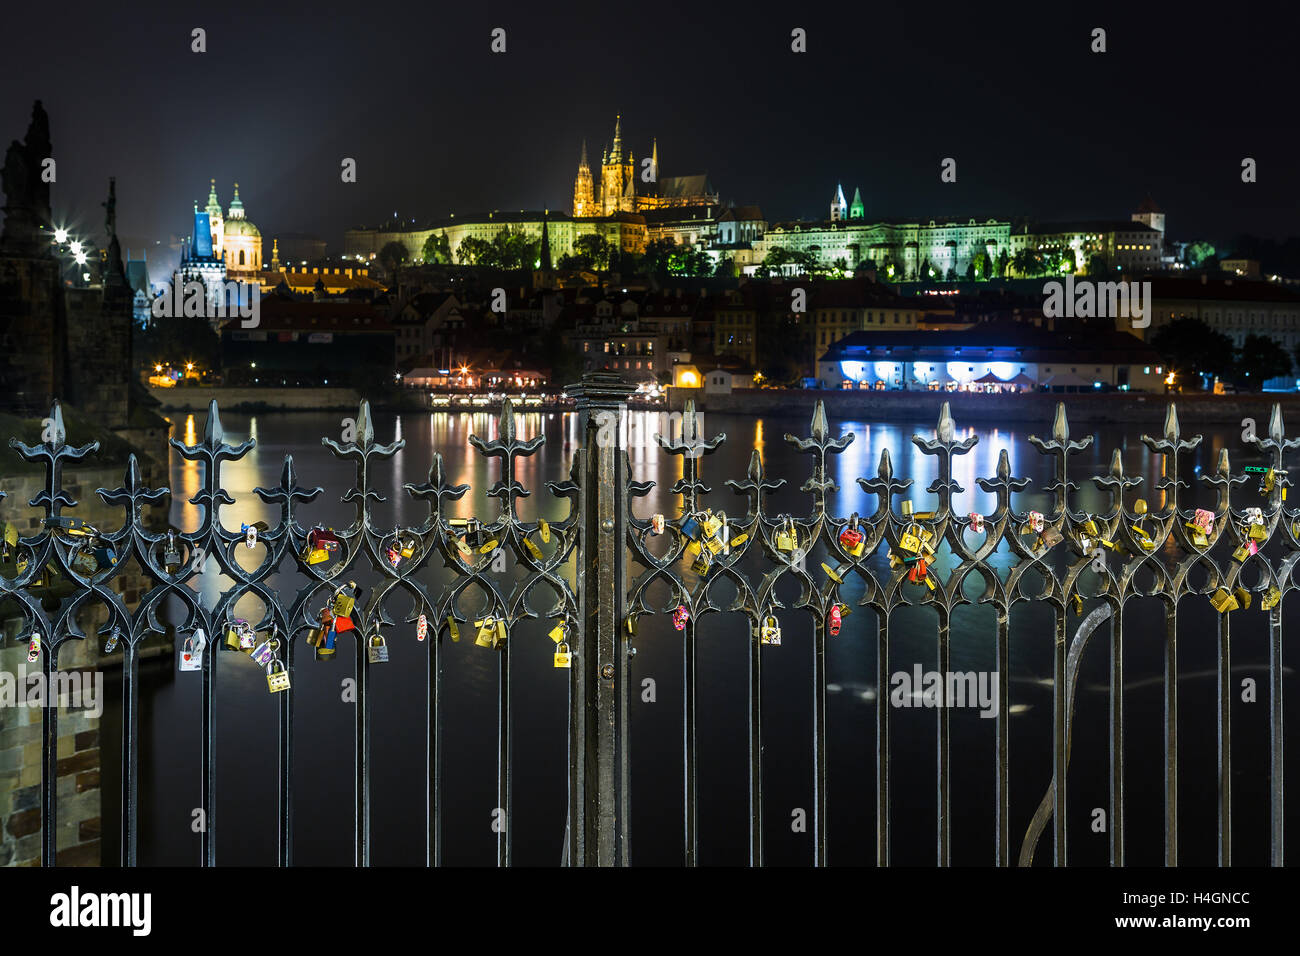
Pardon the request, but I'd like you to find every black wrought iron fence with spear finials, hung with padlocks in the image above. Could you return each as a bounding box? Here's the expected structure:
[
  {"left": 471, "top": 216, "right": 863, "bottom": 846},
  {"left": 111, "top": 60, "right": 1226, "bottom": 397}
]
[{"left": 0, "top": 373, "right": 1300, "bottom": 866}]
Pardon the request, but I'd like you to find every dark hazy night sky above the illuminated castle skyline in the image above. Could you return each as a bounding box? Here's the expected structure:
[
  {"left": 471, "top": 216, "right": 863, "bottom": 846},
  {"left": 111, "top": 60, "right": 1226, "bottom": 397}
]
[{"left": 0, "top": 0, "right": 1300, "bottom": 259}]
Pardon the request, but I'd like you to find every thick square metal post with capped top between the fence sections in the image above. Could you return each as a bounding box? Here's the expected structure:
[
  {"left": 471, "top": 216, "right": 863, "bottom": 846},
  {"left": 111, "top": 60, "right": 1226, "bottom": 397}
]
[{"left": 568, "top": 372, "right": 634, "bottom": 866}]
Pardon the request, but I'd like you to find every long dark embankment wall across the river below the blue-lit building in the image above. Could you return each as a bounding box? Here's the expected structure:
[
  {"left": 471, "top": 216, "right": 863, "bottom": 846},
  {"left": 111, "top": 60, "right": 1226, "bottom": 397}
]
[{"left": 668, "top": 388, "right": 1300, "bottom": 433}]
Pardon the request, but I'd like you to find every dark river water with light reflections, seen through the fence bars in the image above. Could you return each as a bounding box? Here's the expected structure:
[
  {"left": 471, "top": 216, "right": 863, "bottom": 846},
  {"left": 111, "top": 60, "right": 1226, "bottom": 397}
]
[{"left": 103, "top": 412, "right": 1300, "bottom": 865}]
